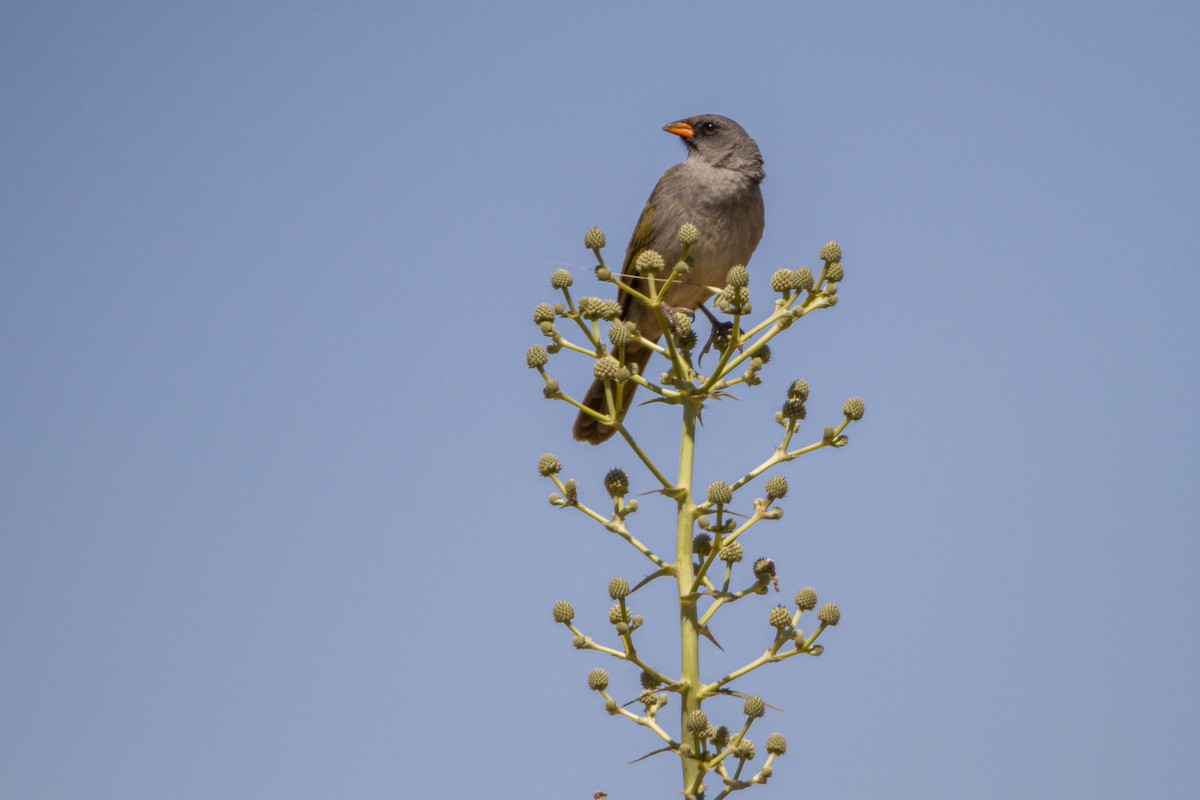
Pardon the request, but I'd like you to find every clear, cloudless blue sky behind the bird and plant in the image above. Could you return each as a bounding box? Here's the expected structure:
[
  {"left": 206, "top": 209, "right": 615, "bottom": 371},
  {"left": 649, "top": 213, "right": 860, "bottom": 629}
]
[{"left": 0, "top": 0, "right": 1200, "bottom": 800}]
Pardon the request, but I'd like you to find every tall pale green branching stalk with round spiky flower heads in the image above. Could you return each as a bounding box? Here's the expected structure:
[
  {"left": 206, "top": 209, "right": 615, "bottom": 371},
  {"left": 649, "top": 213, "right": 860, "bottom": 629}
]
[{"left": 526, "top": 224, "right": 864, "bottom": 800}]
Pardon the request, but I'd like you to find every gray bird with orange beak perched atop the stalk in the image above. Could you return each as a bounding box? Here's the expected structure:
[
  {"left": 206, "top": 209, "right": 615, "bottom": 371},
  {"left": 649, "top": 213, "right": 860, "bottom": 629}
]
[{"left": 574, "top": 114, "right": 767, "bottom": 445}]
